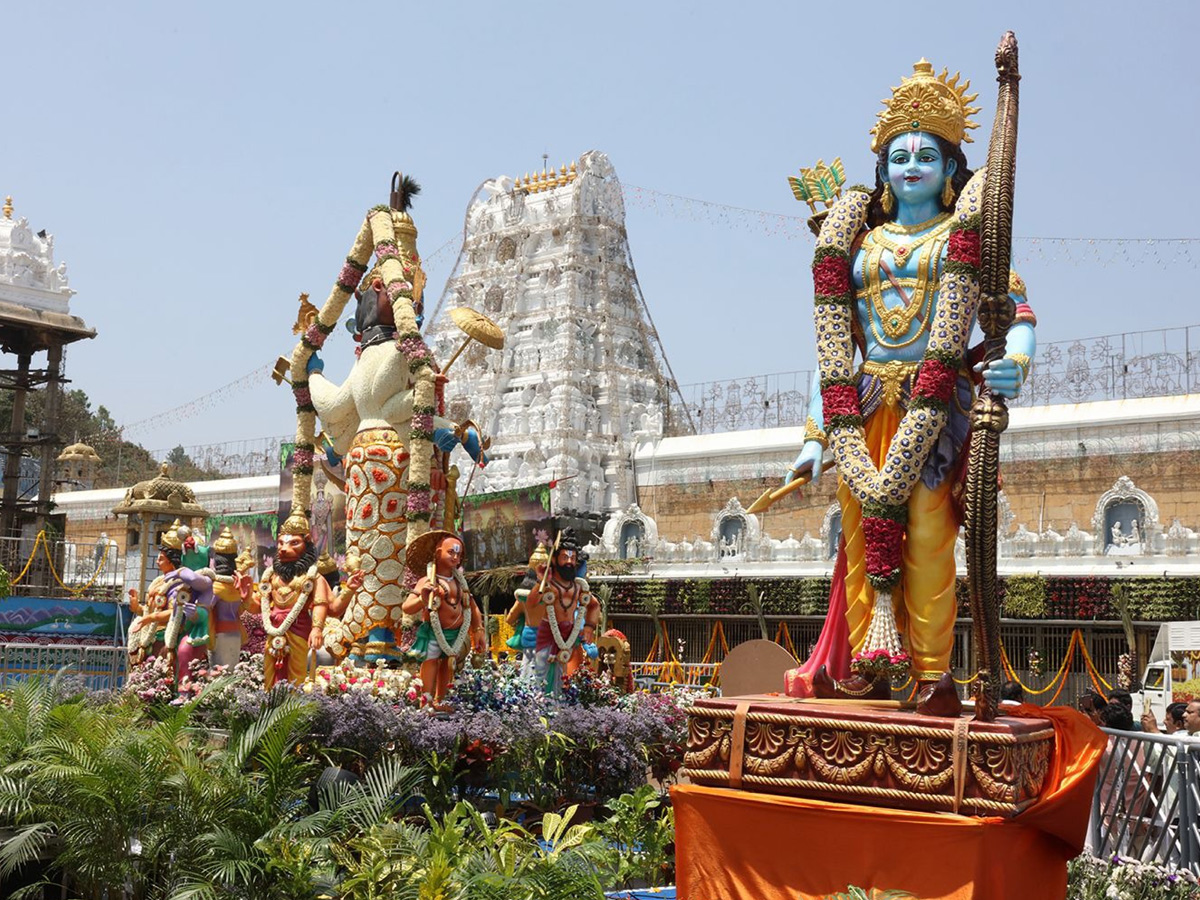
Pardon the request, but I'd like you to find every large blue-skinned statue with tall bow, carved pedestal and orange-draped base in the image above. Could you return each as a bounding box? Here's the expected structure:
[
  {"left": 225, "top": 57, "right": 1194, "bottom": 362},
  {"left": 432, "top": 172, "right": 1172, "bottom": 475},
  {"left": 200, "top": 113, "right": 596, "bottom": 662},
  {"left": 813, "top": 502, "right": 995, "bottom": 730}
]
[{"left": 672, "top": 38, "right": 1105, "bottom": 900}]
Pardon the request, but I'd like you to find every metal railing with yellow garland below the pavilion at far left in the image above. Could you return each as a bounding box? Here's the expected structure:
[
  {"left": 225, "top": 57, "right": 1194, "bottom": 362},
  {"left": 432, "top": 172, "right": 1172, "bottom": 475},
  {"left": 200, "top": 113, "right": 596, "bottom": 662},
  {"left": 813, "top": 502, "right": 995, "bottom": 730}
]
[{"left": 0, "top": 536, "right": 125, "bottom": 601}]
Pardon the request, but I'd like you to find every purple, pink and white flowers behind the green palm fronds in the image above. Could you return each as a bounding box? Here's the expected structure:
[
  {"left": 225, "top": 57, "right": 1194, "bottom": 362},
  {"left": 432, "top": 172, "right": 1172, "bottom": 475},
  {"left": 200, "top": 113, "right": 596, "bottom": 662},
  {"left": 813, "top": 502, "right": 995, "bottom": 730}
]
[{"left": 124, "top": 655, "right": 695, "bottom": 811}]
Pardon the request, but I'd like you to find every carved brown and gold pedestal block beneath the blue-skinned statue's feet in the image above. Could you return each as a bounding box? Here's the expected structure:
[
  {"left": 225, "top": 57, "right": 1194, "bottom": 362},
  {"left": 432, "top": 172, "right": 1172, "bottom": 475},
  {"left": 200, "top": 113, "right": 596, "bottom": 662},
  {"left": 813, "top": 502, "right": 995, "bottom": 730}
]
[{"left": 683, "top": 695, "right": 1055, "bottom": 816}]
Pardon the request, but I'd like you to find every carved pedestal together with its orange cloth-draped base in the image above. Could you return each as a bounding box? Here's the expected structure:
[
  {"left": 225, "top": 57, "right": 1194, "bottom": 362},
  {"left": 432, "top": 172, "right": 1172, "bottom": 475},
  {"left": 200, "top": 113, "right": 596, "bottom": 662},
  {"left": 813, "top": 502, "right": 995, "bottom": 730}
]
[{"left": 671, "top": 696, "right": 1105, "bottom": 900}]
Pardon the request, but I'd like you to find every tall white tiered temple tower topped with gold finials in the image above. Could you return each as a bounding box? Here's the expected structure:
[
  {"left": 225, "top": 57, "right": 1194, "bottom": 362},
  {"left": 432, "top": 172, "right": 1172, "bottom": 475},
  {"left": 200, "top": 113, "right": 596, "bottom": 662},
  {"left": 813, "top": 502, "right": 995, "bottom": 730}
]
[{"left": 428, "top": 151, "right": 686, "bottom": 518}]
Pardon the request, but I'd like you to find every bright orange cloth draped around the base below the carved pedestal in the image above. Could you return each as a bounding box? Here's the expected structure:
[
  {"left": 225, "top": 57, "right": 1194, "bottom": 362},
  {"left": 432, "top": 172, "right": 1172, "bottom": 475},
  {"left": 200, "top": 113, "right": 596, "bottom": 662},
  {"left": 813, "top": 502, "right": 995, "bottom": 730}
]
[{"left": 671, "top": 707, "right": 1105, "bottom": 900}]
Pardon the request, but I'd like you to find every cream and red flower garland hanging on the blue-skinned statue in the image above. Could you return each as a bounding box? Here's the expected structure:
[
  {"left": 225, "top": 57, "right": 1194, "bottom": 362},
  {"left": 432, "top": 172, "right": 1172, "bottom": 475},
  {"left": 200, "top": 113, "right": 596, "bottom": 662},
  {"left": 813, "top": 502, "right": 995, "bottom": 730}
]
[{"left": 812, "top": 169, "right": 985, "bottom": 654}]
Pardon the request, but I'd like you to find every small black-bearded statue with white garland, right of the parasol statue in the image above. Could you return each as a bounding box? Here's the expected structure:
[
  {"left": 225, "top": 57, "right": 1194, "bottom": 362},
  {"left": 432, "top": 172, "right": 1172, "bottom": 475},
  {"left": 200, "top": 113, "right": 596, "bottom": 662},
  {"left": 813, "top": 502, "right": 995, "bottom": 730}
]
[{"left": 526, "top": 528, "right": 600, "bottom": 697}]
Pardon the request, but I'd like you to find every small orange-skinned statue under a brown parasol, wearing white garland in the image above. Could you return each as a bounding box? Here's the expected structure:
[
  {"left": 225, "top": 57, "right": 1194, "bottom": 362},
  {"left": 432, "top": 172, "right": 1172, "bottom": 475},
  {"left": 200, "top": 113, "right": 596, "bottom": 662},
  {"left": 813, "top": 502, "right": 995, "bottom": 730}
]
[{"left": 403, "top": 530, "right": 487, "bottom": 703}]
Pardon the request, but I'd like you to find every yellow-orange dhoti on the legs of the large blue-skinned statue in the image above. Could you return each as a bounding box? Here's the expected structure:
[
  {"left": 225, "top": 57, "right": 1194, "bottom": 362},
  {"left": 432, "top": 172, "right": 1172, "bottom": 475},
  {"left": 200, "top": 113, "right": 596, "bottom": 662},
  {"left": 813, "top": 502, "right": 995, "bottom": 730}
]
[{"left": 838, "top": 403, "right": 960, "bottom": 680}]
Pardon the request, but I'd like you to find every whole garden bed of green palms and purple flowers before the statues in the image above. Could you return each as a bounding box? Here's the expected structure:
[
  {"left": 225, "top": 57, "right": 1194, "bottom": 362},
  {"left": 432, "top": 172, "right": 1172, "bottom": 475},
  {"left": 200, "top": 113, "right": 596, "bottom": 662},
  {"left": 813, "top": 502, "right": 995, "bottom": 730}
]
[{"left": 0, "top": 658, "right": 691, "bottom": 900}]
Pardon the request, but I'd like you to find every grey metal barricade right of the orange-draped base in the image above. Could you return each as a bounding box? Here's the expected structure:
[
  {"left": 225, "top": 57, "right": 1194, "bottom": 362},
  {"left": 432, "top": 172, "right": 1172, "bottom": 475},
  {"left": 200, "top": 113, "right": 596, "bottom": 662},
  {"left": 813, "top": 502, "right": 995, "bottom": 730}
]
[{"left": 1088, "top": 728, "right": 1200, "bottom": 875}]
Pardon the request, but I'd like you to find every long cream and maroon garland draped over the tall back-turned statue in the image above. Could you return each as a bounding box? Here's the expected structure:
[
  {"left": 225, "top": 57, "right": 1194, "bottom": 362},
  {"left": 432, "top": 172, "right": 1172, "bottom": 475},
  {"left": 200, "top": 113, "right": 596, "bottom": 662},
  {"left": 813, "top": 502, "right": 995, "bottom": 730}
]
[{"left": 290, "top": 206, "right": 437, "bottom": 614}]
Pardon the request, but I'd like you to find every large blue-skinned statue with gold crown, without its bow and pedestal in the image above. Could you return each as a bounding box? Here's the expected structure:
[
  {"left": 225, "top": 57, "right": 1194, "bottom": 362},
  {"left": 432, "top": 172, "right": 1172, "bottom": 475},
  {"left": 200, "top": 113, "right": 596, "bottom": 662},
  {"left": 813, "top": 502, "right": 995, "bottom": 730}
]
[{"left": 785, "top": 60, "right": 1036, "bottom": 715}]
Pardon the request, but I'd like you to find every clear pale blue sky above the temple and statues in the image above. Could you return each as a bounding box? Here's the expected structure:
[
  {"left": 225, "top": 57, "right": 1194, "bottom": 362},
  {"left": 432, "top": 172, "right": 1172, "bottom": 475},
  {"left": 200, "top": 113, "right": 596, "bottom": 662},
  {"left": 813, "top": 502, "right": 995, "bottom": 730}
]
[{"left": 0, "top": 0, "right": 1200, "bottom": 449}]
